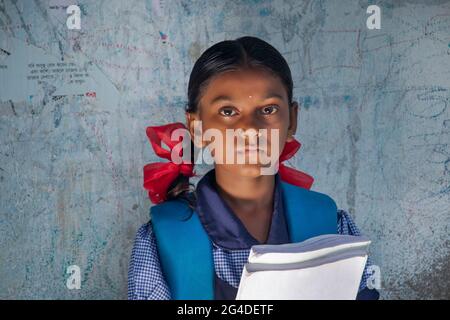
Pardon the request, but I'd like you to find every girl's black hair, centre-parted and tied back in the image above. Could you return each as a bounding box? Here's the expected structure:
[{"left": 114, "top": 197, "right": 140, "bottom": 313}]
[{"left": 167, "top": 36, "right": 293, "bottom": 207}]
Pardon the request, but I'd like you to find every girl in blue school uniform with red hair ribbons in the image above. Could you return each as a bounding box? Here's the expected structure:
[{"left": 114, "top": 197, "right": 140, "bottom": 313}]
[{"left": 128, "top": 37, "right": 379, "bottom": 299}]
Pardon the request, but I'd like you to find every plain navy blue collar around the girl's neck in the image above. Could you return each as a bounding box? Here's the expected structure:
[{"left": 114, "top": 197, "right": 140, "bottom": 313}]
[{"left": 196, "top": 169, "right": 289, "bottom": 249}]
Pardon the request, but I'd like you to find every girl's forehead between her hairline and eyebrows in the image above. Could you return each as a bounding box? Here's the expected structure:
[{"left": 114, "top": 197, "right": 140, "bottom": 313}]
[{"left": 201, "top": 69, "right": 287, "bottom": 103}]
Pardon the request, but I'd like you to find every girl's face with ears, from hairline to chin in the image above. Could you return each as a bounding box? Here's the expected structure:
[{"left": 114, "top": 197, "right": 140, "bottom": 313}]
[{"left": 186, "top": 69, "right": 298, "bottom": 177}]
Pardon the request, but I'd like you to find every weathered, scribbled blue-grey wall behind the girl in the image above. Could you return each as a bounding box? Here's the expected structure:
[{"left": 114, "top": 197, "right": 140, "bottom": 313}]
[{"left": 0, "top": 0, "right": 450, "bottom": 299}]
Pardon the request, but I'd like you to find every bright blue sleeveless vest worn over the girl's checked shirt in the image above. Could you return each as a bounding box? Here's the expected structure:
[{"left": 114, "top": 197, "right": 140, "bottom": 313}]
[{"left": 150, "top": 182, "right": 337, "bottom": 300}]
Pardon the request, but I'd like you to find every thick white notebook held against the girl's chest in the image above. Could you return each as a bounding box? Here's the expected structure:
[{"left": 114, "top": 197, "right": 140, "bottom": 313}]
[{"left": 236, "top": 234, "right": 370, "bottom": 300}]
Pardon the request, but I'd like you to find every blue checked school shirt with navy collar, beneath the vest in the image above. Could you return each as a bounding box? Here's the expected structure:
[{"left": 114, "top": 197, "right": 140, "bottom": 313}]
[{"left": 128, "top": 169, "right": 379, "bottom": 300}]
